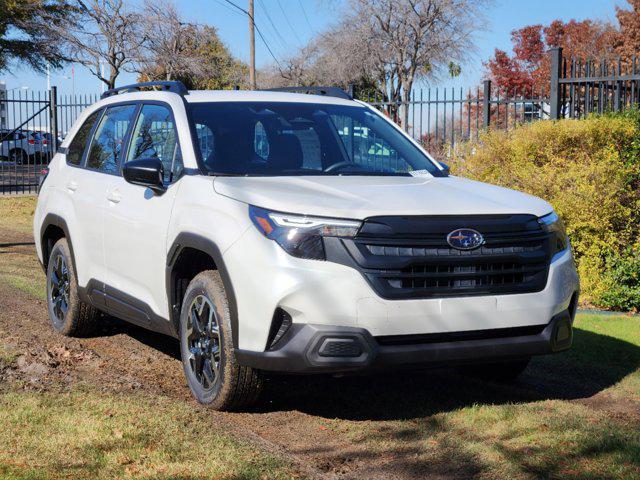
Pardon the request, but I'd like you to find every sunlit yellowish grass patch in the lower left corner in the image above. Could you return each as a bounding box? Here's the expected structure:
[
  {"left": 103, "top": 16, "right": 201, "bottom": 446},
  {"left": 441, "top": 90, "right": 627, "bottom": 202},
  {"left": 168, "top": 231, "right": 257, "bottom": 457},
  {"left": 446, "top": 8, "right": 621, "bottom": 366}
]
[{"left": 0, "top": 389, "right": 291, "bottom": 479}]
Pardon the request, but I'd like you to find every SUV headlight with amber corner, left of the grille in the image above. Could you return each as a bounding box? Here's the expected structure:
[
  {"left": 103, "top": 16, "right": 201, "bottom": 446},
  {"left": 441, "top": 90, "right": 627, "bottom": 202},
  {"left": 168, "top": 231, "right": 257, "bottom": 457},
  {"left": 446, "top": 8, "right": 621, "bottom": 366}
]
[{"left": 249, "top": 205, "right": 362, "bottom": 260}]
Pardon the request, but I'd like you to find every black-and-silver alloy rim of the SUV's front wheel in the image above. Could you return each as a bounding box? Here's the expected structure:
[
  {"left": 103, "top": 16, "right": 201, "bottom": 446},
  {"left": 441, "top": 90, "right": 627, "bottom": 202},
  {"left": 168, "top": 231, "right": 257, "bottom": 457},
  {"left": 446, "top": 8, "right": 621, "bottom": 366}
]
[{"left": 187, "top": 295, "right": 221, "bottom": 390}]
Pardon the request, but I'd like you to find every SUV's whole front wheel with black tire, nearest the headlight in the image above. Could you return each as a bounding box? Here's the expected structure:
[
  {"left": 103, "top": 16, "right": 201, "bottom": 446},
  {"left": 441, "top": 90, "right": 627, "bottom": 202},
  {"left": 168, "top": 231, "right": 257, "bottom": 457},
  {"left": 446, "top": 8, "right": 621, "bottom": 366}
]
[{"left": 180, "top": 270, "right": 262, "bottom": 410}]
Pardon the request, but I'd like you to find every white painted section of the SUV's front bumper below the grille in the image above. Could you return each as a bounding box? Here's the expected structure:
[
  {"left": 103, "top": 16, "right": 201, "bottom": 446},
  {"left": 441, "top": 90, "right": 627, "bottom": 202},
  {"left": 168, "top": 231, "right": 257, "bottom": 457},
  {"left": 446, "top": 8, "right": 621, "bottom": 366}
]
[{"left": 224, "top": 228, "right": 579, "bottom": 354}]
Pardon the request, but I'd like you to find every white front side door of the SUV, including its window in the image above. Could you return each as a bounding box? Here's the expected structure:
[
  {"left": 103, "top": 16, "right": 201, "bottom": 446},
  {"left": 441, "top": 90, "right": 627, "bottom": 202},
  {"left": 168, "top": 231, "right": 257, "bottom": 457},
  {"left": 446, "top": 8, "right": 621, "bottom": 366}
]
[{"left": 104, "top": 103, "right": 184, "bottom": 326}]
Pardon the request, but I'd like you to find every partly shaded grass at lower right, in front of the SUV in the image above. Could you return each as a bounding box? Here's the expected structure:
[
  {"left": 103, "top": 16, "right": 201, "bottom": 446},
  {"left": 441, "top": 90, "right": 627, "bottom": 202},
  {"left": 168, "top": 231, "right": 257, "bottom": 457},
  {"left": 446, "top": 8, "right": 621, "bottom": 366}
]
[{"left": 328, "top": 314, "right": 640, "bottom": 479}]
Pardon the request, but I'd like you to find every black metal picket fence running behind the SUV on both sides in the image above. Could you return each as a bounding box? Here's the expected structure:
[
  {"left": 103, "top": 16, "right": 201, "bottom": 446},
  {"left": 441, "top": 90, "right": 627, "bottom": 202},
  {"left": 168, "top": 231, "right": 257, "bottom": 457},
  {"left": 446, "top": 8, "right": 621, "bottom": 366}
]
[{"left": 0, "top": 48, "right": 640, "bottom": 194}]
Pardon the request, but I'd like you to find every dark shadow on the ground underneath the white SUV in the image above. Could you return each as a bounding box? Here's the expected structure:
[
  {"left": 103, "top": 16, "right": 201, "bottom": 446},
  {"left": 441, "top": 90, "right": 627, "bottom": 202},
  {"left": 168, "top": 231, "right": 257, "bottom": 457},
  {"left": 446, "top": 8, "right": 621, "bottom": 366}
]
[{"left": 97, "top": 317, "right": 640, "bottom": 420}]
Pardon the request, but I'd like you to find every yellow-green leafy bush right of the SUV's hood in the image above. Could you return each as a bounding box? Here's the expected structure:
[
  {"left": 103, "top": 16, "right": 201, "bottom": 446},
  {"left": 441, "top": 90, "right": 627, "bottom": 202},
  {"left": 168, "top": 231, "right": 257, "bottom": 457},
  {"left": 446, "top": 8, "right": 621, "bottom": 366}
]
[{"left": 450, "top": 112, "right": 640, "bottom": 310}]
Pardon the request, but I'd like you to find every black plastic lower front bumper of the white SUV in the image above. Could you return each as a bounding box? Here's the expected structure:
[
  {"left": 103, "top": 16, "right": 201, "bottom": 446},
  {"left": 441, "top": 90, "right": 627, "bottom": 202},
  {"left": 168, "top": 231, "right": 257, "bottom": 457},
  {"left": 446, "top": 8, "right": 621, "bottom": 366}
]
[{"left": 236, "top": 300, "right": 576, "bottom": 373}]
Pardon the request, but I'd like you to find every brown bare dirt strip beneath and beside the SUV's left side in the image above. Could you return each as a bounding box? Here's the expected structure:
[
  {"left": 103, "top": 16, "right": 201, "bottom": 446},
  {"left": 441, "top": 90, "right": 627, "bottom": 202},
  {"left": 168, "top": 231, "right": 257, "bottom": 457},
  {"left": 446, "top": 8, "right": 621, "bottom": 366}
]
[{"left": 0, "top": 264, "right": 401, "bottom": 478}]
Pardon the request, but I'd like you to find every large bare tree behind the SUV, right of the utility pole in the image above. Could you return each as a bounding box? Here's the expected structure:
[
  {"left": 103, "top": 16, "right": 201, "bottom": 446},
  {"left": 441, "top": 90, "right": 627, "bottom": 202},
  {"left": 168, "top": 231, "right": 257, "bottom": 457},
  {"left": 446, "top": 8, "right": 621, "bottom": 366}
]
[{"left": 270, "top": 0, "right": 490, "bottom": 125}]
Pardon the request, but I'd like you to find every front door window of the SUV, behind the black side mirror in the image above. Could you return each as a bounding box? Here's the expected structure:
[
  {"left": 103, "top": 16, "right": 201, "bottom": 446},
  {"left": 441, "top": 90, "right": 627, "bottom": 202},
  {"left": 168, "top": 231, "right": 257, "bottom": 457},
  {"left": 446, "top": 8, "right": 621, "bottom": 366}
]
[{"left": 127, "top": 105, "right": 184, "bottom": 183}]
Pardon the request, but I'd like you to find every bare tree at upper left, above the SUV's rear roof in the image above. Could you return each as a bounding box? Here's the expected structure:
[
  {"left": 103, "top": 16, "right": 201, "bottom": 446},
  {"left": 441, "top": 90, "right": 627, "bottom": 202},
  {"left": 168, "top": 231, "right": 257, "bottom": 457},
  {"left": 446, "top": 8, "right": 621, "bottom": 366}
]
[{"left": 55, "top": 0, "right": 145, "bottom": 88}]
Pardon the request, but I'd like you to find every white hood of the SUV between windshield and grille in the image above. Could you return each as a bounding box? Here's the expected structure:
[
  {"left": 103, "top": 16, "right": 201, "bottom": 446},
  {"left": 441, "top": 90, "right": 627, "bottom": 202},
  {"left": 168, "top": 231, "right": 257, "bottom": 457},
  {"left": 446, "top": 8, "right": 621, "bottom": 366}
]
[{"left": 214, "top": 176, "right": 552, "bottom": 219}]
